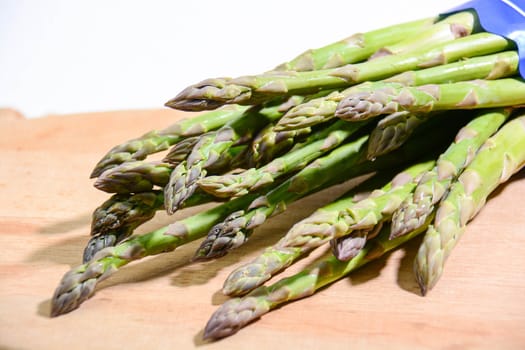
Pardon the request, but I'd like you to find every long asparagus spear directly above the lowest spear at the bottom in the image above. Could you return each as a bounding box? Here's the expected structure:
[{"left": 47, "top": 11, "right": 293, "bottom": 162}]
[{"left": 223, "top": 162, "right": 433, "bottom": 295}]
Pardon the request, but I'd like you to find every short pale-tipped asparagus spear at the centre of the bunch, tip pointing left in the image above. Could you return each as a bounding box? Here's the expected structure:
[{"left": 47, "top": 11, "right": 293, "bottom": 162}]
[{"left": 198, "top": 121, "right": 363, "bottom": 198}]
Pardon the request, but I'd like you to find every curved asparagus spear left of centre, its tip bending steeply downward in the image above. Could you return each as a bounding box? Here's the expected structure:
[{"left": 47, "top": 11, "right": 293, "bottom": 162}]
[{"left": 164, "top": 100, "right": 298, "bottom": 214}]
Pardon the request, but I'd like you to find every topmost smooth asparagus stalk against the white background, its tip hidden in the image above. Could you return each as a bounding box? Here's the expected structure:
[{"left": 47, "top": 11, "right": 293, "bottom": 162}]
[{"left": 275, "top": 17, "right": 438, "bottom": 72}]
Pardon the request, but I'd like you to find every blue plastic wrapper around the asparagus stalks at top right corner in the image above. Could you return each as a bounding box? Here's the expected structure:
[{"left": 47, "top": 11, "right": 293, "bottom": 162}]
[{"left": 444, "top": 0, "right": 525, "bottom": 78}]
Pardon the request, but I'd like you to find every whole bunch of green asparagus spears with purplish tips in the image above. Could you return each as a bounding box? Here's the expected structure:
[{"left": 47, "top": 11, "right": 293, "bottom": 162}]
[{"left": 52, "top": 11, "right": 525, "bottom": 339}]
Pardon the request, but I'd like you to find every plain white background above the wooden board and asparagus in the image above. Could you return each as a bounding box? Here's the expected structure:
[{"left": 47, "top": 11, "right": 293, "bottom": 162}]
[{"left": 0, "top": 0, "right": 464, "bottom": 118}]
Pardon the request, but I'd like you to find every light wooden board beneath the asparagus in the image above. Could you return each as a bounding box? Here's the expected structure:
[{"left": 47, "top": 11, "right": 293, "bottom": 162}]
[{"left": 0, "top": 110, "right": 525, "bottom": 350}]
